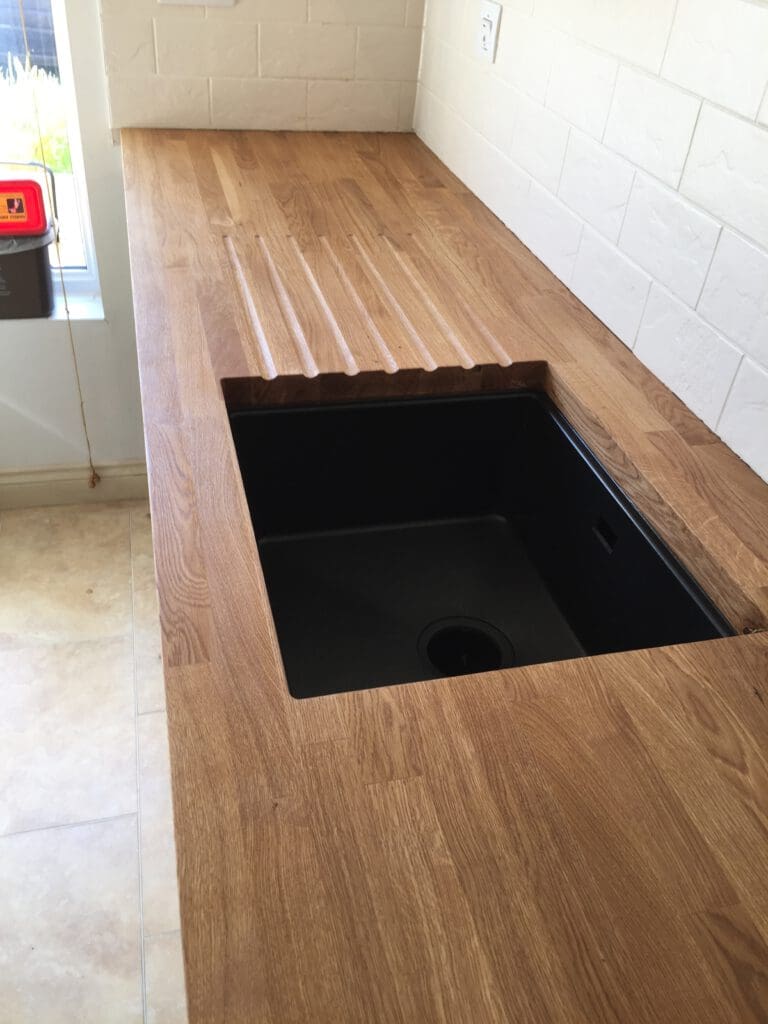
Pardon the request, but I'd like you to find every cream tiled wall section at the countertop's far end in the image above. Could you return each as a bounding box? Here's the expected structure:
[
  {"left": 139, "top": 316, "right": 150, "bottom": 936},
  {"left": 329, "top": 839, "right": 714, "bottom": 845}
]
[{"left": 101, "top": 0, "right": 424, "bottom": 131}]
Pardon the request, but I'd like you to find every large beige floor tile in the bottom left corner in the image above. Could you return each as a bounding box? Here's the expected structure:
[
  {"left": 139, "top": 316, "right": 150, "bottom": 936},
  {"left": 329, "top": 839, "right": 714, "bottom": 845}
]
[{"left": 0, "top": 816, "right": 141, "bottom": 1024}]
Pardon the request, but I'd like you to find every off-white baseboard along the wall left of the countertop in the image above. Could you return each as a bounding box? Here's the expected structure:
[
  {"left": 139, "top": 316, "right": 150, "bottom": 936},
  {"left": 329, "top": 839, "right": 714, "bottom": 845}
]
[{"left": 0, "top": 462, "right": 147, "bottom": 509}]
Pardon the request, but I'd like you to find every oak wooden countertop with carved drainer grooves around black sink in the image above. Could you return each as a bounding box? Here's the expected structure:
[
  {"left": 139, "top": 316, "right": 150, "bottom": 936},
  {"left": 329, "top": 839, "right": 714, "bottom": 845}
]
[{"left": 123, "top": 130, "right": 768, "bottom": 1024}]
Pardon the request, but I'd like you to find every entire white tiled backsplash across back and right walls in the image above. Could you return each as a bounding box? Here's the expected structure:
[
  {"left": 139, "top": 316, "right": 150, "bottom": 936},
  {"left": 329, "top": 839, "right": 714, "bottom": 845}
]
[{"left": 101, "top": 0, "right": 768, "bottom": 479}]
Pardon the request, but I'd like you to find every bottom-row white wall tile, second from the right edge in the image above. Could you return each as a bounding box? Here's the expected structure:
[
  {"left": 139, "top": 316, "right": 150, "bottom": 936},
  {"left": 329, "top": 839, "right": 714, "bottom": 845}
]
[{"left": 635, "top": 285, "right": 741, "bottom": 428}]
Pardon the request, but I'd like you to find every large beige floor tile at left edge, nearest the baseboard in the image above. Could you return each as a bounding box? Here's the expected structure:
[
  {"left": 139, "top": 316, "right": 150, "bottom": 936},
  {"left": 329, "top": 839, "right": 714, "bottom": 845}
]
[{"left": 0, "top": 506, "right": 131, "bottom": 647}]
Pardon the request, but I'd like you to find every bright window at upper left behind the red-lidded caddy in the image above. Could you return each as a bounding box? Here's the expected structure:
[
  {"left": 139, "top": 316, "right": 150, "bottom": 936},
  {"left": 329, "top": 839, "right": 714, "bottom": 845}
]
[{"left": 0, "top": 0, "right": 98, "bottom": 296}]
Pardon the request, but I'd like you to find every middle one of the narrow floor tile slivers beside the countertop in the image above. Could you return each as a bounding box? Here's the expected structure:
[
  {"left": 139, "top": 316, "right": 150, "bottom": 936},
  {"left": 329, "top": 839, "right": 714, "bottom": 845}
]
[{"left": 138, "top": 712, "right": 179, "bottom": 935}]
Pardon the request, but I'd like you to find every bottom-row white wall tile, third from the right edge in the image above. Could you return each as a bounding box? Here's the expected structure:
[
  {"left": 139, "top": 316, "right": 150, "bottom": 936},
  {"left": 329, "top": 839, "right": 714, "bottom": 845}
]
[{"left": 570, "top": 227, "right": 650, "bottom": 348}]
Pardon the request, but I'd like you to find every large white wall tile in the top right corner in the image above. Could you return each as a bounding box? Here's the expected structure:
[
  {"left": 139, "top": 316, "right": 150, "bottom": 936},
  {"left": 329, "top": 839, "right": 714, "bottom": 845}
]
[{"left": 664, "top": 0, "right": 768, "bottom": 118}]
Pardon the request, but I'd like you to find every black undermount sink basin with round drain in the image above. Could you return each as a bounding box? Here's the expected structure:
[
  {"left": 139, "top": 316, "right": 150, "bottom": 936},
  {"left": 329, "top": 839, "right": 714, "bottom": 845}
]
[{"left": 230, "top": 391, "right": 733, "bottom": 697}]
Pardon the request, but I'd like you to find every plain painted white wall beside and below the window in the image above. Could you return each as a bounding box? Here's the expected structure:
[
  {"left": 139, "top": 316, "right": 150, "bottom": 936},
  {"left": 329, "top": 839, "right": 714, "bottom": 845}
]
[{"left": 0, "top": 0, "right": 144, "bottom": 473}]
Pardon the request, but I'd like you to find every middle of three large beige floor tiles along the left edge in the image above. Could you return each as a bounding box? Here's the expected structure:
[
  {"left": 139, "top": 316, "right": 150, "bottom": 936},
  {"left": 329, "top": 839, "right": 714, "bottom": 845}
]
[{"left": 0, "top": 637, "right": 136, "bottom": 834}]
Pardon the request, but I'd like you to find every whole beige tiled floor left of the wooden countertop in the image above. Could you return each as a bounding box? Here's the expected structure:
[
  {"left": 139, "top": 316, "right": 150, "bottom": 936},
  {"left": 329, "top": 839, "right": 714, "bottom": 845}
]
[{"left": 0, "top": 502, "right": 186, "bottom": 1024}]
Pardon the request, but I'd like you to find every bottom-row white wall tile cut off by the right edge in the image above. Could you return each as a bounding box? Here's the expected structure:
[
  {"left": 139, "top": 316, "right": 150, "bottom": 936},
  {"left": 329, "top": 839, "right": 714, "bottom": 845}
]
[{"left": 718, "top": 359, "right": 768, "bottom": 479}]
